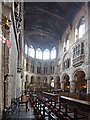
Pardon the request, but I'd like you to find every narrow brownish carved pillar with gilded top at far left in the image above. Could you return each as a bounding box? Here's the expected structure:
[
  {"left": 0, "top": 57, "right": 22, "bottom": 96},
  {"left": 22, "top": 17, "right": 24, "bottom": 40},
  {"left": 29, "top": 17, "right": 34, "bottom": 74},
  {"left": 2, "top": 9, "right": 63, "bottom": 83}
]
[{"left": 2, "top": 16, "right": 11, "bottom": 107}]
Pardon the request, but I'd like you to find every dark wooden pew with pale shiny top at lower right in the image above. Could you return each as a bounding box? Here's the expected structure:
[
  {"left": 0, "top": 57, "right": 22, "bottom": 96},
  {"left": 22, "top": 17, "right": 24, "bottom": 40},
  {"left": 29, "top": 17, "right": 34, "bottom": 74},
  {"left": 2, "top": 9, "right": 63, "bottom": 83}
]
[{"left": 60, "top": 96, "right": 90, "bottom": 120}]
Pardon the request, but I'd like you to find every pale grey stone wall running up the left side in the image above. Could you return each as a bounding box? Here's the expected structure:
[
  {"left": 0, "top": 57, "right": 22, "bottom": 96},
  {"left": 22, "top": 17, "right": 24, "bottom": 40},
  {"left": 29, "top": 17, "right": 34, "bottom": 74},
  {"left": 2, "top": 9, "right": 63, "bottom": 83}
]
[{"left": 0, "top": 2, "right": 23, "bottom": 117}]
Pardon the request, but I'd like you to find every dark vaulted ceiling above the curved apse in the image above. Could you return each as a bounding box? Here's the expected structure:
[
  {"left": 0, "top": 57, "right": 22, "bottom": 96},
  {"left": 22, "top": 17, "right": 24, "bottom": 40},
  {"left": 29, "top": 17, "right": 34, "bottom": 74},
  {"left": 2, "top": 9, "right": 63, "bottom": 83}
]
[{"left": 24, "top": 2, "right": 84, "bottom": 47}]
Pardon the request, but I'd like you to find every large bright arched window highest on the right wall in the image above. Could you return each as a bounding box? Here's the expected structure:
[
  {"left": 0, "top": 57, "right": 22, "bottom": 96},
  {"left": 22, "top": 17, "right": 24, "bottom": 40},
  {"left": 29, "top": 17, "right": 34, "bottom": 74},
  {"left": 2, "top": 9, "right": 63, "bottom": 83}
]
[{"left": 78, "top": 17, "right": 85, "bottom": 39}]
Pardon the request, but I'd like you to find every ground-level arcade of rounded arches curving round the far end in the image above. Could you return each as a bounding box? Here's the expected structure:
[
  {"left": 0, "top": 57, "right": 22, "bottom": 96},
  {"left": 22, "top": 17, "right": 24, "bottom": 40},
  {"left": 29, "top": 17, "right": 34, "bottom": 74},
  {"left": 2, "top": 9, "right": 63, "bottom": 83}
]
[{"left": 25, "top": 70, "right": 87, "bottom": 94}]
